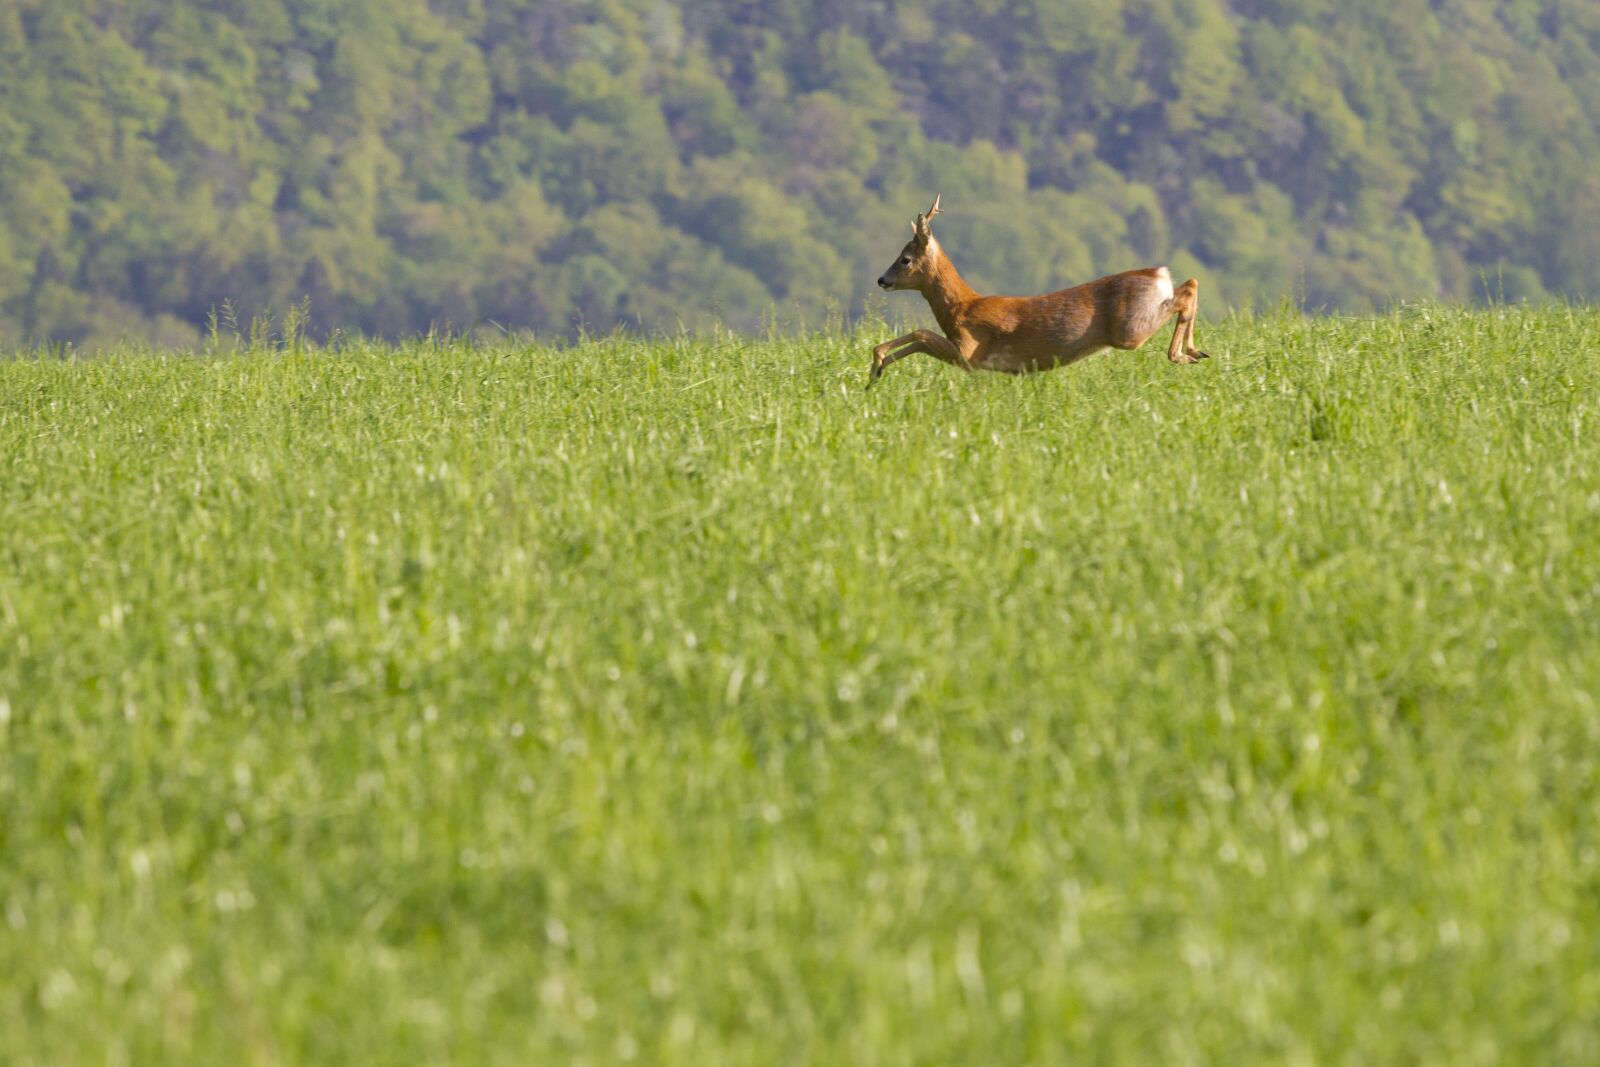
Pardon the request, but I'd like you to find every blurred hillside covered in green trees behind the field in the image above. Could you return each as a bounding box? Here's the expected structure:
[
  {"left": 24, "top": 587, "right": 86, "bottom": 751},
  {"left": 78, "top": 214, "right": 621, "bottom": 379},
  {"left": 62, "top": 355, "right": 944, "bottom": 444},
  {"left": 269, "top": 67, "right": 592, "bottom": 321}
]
[{"left": 0, "top": 0, "right": 1600, "bottom": 344}]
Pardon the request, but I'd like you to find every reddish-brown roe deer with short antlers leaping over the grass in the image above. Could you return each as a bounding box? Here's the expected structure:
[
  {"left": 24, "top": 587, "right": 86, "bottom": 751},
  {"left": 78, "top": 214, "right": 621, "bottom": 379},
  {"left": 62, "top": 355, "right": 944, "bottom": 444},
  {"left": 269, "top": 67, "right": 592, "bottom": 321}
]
[{"left": 867, "top": 197, "right": 1210, "bottom": 389}]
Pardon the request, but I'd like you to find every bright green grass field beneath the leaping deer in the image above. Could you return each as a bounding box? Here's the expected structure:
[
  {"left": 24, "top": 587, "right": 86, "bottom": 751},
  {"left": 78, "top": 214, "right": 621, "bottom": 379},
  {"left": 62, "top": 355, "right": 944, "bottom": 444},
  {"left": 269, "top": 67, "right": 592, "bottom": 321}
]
[{"left": 0, "top": 307, "right": 1600, "bottom": 1065}]
